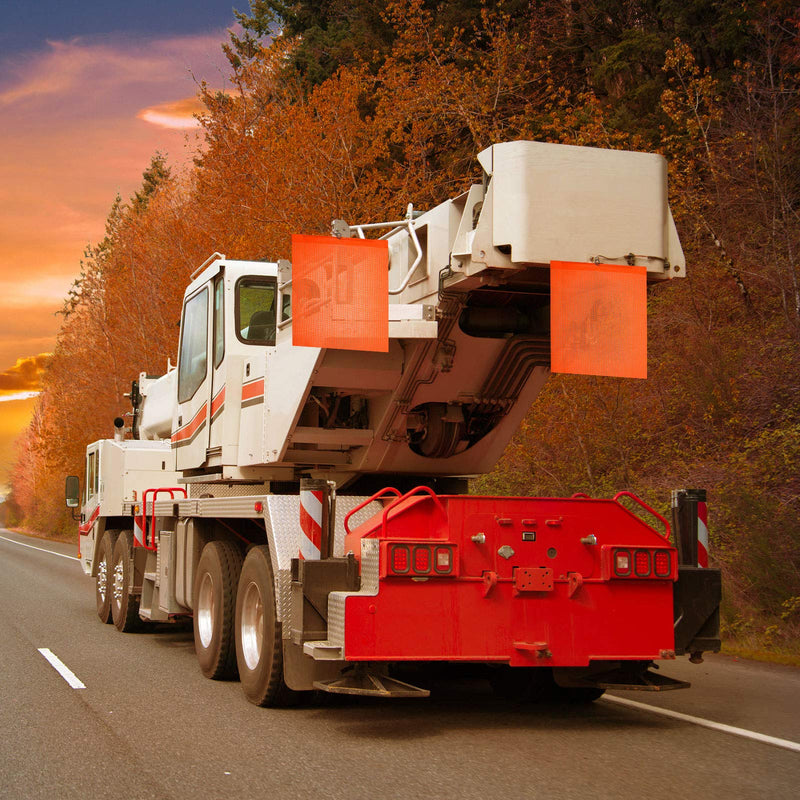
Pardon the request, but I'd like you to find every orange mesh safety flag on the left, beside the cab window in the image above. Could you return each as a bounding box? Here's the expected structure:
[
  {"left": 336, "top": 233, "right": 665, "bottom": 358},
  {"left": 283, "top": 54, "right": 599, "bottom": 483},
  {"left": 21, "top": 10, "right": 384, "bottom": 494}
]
[{"left": 292, "top": 236, "right": 389, "bottom": 353}]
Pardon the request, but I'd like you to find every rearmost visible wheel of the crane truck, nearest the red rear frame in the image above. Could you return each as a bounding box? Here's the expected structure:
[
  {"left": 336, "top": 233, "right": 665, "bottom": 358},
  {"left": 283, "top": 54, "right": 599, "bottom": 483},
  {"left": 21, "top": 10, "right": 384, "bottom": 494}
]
[{"left": 236, "top": 545, "right": 301, "bottom": 706}]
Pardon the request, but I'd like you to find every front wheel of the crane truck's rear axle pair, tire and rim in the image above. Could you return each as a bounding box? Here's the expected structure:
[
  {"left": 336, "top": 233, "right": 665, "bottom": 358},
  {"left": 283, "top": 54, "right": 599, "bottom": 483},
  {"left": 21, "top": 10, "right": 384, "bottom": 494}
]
[{"left": 192, "top": 541, "right": 242, "bottom": 680}]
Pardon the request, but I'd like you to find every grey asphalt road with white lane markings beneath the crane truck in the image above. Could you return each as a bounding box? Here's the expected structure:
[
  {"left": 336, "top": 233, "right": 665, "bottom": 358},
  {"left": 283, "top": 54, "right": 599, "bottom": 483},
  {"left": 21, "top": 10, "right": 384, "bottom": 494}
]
[{"left": 0, "top": 529, "right": 800, "bottom": 800}]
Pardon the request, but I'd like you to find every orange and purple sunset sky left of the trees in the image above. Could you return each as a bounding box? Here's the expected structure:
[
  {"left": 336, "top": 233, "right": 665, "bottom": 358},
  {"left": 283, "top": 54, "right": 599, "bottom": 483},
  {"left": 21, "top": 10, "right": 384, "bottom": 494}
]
[{"left": 0, "top": 0, "right": 241, "bottom": 494}]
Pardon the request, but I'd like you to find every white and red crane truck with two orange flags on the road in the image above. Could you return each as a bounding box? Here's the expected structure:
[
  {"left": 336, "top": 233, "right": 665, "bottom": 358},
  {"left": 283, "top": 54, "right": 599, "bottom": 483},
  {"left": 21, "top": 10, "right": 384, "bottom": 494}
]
[{"left": 67, "top": 141, "right": 720, "bottom": 706}]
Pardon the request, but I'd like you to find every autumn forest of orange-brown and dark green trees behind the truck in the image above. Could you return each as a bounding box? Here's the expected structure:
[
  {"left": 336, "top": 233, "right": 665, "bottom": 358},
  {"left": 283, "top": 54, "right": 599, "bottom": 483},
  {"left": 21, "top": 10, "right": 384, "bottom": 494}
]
[{"left": 6, "top": 0, "right": 800, "bottom": 656}]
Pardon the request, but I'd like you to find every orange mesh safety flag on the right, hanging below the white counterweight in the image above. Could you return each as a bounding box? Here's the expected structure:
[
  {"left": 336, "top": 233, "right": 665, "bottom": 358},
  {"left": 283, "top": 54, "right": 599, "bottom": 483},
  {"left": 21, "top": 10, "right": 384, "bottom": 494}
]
[{"left": 550, "top": 261, "right": 647, "bottom": 378}]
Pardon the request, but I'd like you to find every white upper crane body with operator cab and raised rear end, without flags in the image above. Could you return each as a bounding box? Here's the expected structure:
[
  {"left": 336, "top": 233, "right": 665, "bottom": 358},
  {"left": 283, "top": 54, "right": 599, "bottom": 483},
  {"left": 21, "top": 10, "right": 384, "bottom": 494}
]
[{"left": 134, "top": 142, "right": 685, "bottom": 486}]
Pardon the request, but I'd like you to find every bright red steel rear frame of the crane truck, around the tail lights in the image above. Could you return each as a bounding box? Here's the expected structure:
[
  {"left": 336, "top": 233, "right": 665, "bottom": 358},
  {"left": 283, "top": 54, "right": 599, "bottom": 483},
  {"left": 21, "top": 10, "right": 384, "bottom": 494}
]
[{"left": 345, "top": 487, "right": 678, "bottom": 667}]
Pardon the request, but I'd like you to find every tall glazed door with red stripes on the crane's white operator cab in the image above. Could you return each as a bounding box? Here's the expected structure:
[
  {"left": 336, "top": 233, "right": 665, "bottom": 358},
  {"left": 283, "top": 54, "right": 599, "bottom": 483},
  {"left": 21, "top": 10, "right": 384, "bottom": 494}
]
[{"left": 172, "top": 283, "right": 213, "bottom": 470}]
